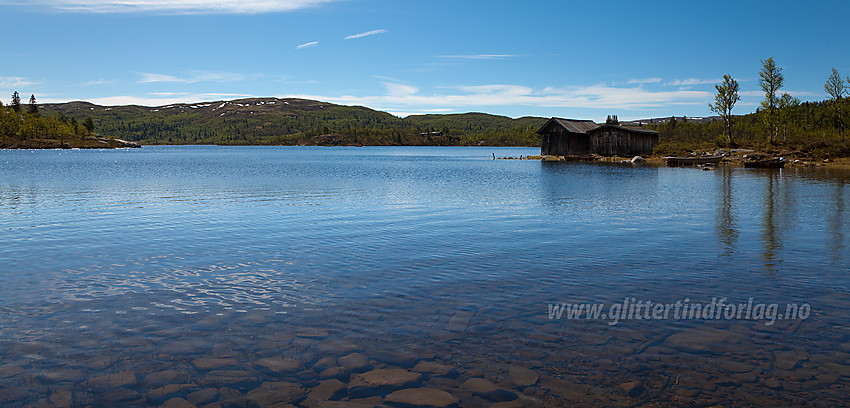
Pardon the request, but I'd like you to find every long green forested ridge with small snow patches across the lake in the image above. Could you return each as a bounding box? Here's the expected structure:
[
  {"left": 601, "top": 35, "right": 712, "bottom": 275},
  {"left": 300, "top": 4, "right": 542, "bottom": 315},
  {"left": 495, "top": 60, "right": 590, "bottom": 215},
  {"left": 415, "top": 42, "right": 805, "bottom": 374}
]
[{"left": 41, "top": 98, "right": 548, "bottom": 146}]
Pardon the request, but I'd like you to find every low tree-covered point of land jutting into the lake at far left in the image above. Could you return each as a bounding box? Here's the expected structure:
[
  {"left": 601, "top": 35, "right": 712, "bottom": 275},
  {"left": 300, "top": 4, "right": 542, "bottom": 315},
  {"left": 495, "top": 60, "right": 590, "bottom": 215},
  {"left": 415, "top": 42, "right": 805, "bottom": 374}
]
[{"left": 0, "top": 92, "right": 141, "bottom": 149}]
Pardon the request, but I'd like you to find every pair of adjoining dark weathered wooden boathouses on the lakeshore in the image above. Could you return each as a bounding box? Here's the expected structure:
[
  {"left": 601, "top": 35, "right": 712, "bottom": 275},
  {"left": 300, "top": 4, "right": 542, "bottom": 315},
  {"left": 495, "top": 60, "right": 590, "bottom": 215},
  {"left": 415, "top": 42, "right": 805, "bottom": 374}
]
[{"left": 537, "top": 118, "right": 659, "bottom": 156}]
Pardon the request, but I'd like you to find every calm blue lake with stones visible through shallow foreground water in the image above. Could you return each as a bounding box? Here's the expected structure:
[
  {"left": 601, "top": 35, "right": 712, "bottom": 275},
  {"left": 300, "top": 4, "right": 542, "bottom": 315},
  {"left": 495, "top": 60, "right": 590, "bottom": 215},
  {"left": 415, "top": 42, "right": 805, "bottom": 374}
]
[{"left": 0, "top": 146, "right": 850, "bottom": 407}]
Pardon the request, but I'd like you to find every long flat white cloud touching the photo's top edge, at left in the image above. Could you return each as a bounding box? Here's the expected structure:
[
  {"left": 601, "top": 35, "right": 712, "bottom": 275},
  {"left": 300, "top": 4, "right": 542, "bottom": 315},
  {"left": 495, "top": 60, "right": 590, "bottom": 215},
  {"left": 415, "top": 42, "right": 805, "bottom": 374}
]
[{"left": 22, "top": 0, "right": 338, "bottom": 14}]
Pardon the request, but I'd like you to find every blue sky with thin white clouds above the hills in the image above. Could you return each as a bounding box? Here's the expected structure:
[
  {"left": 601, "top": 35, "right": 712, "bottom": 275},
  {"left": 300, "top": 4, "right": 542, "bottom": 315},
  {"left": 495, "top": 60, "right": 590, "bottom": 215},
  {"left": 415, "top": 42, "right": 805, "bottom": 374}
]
[{"left": 0, "top": 0, "right": 850, "bottom": 120}]
